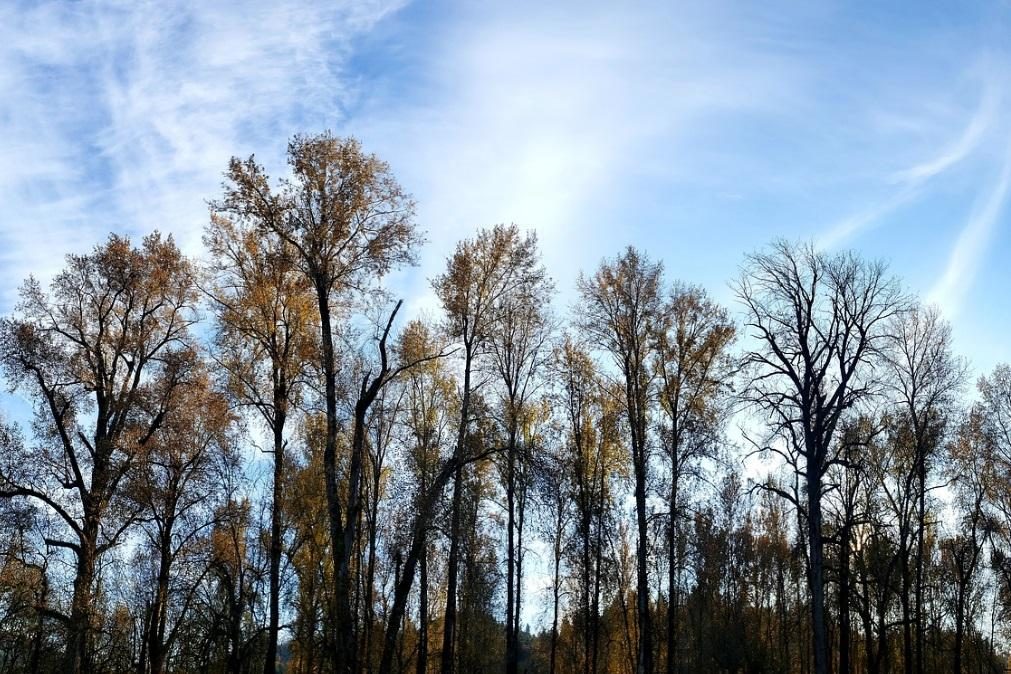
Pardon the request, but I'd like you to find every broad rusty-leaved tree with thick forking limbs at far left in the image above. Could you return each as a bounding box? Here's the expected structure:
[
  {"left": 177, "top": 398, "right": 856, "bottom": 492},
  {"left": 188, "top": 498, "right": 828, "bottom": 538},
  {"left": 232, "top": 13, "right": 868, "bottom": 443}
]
[{"left": 0, "top": 233, "right": 196, "bottom": 674}]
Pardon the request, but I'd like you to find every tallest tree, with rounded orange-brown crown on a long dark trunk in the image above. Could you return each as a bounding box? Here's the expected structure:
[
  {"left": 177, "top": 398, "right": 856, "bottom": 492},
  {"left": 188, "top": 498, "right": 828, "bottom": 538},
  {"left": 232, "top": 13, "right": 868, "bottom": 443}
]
[{"left": 219, "top": 133, "right": 421, "bottom": 673}]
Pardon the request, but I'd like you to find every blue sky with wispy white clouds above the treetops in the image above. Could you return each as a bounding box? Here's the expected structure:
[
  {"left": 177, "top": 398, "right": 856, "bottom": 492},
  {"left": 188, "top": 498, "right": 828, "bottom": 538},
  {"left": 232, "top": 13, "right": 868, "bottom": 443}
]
[{"left": 0, "top": 0, "right": 1011, "bottom": 626}]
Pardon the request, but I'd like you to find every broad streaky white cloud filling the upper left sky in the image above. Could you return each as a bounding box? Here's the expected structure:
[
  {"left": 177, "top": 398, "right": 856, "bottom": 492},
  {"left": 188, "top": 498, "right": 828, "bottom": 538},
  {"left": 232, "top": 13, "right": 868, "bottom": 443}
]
[{"left": 0, "top": 0, "right": 400, "bottom": 306}]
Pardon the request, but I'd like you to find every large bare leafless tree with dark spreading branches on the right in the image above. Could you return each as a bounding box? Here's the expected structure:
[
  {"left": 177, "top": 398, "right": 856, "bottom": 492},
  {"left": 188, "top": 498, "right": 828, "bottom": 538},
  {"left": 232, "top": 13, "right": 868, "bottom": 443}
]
[{"left": 736, "top": 242, "right": 905, "bottom": 674}]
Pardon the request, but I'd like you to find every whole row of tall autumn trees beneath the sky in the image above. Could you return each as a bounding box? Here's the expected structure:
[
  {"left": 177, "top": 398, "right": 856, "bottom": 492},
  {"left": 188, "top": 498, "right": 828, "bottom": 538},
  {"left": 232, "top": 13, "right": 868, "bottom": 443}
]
[{"left": 0, "top": 132, "right": 1011, "bottom": 674}]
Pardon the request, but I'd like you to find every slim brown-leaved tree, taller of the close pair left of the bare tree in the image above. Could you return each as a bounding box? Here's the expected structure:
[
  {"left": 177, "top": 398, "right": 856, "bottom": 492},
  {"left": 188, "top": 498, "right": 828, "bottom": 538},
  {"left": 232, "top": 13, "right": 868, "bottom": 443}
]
[{"left": 578, "top": 248, "right": 663, "bottom": 674}]
